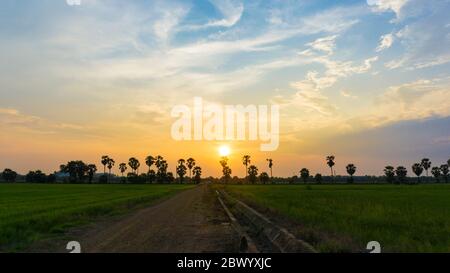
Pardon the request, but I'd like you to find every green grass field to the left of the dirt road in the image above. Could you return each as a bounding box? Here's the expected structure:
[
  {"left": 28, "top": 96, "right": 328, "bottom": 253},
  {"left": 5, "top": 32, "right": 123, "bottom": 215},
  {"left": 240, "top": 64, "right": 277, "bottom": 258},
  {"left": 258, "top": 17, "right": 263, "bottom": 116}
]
[{"left": 0, "top": 184, "right": 192, "bottom": 251}]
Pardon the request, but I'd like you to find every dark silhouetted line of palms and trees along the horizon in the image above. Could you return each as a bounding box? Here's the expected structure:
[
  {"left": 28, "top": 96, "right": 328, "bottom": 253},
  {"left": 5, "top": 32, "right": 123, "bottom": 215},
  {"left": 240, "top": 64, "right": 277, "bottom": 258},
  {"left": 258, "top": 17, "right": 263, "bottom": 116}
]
[{"left": 1, "top": 155, "right": 450, "bottom": 184}]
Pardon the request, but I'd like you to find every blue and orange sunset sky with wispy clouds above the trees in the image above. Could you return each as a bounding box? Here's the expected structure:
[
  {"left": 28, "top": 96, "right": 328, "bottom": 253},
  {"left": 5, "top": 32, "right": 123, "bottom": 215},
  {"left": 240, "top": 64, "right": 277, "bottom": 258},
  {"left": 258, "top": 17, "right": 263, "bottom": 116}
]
[{"left": 0, "top": 0, "right": 450, "bottom": 176}]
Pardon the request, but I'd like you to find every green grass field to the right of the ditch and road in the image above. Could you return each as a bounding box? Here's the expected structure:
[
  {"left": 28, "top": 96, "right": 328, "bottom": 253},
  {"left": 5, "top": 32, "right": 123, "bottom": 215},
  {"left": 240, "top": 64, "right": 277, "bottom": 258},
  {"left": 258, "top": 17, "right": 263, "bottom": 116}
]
[{"left": 227, "top": 184, "right": 450, "bottom": 252}]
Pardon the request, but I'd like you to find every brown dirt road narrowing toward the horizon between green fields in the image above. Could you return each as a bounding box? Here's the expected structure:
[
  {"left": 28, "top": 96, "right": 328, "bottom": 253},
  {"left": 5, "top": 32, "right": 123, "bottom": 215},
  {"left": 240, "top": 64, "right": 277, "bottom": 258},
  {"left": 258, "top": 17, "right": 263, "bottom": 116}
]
[{"left": 73, "top": 185, "right": 239, "bottom": 253}]
